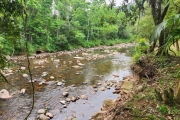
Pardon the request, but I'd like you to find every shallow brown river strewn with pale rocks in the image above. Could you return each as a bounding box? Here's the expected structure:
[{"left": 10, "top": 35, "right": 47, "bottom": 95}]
[{"left": 0, "top": 43, "right": 134, "bottom": 120}]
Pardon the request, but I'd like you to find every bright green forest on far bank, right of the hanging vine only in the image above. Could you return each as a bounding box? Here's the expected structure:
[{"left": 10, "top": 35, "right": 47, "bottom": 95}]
[{"left": 21, "top": 0, "right": 132, "bottom": 52}]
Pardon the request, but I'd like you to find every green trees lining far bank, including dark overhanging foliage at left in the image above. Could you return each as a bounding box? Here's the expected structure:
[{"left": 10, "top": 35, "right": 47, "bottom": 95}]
[{"left": 0, "top": 0, "right": 135, "bottom": 55}]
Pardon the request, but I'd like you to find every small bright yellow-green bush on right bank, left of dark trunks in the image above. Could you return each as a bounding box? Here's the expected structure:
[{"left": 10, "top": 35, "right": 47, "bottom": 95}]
[{"left": 133, "top": 38, "right": 149, "bottom": 62}]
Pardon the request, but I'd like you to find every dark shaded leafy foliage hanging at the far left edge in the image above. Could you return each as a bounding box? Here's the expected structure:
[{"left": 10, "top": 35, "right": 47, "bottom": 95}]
[{"left": 0, "top": 0, "right": 24, "bottom": 69}]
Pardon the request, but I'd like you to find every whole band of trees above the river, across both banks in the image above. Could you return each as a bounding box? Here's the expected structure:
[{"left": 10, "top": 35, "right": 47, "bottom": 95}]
[{"left": 0, "top": 0, "right": 179, "bottom": 58}]
